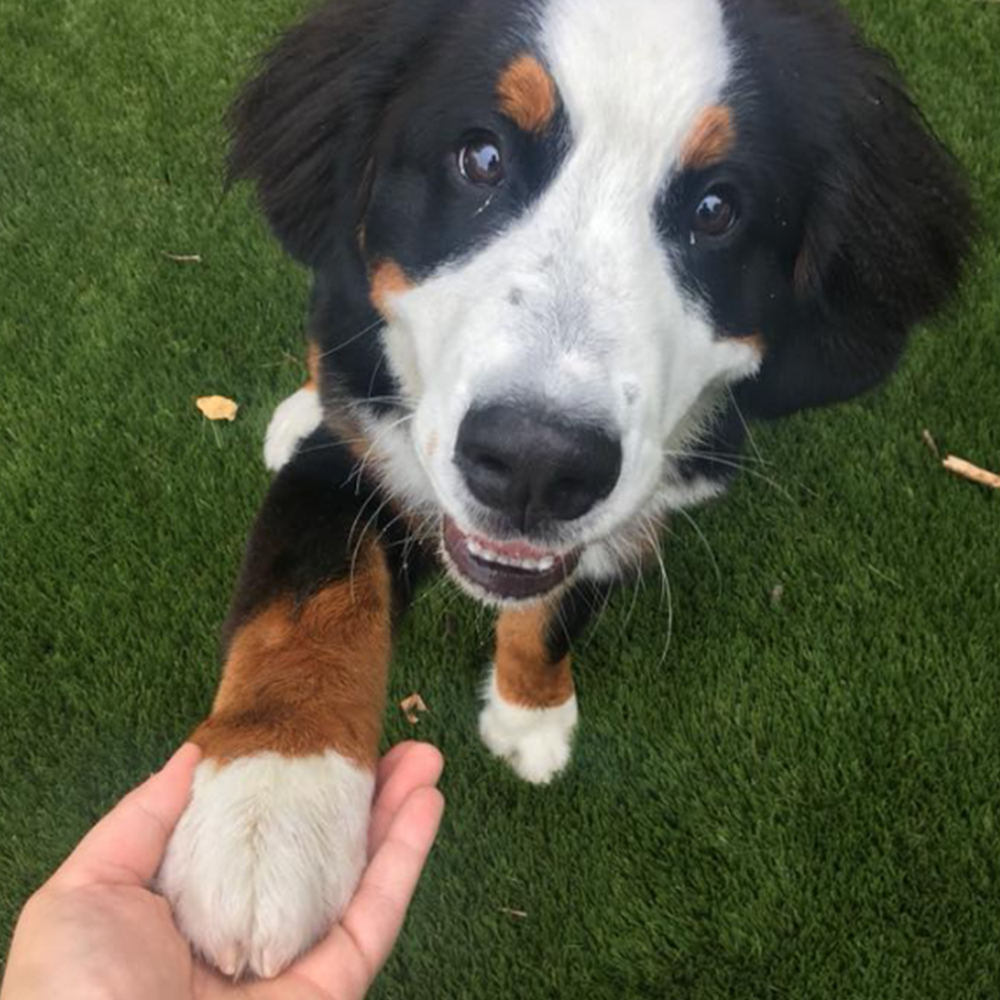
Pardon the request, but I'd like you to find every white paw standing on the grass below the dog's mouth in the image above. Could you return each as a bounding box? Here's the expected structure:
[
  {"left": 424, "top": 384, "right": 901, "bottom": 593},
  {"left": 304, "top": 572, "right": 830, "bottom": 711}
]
[{"left": 479, "top": 672, "right": 580, "bottom": 785}]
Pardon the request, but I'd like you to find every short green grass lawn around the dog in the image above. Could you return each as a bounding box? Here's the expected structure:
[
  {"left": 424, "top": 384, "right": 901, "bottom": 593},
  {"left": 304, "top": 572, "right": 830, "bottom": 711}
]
[{"left": 0, "top": 0, "right": 1000, "bottom": 1000}]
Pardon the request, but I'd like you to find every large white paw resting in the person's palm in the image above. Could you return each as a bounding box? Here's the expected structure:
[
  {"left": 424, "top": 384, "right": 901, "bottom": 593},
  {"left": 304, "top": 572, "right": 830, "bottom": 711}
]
[{"left": 157, "top": 752, "right": 374, "bottom": 978}]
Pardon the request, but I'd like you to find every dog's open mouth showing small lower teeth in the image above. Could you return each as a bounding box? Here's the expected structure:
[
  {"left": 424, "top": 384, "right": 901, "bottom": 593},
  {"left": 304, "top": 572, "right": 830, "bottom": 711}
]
[{"left": 444, "top": 517, "right": 582, "bottom": 601}]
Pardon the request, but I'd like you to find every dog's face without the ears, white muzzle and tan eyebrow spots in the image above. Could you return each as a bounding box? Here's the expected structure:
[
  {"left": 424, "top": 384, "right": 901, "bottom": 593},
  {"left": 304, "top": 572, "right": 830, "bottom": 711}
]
[{"left": 365, "top": 0, "right": 761, "bottom": 596}]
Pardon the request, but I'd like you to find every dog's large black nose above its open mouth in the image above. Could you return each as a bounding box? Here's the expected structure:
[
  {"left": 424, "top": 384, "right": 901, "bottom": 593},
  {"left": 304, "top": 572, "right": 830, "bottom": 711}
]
[{"left": 455, "top": 405, "right": 622, "bottom": 533}]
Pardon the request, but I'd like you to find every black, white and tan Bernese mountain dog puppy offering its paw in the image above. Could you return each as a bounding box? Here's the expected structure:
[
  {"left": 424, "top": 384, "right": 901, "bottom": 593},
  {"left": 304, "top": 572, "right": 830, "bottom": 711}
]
[{"left": 159, "top": 0, "right": 972, "bottom": 977}]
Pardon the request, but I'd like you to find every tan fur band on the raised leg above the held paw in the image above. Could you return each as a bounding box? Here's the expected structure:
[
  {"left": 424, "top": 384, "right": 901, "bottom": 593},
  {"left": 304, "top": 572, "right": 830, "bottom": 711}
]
[{"left": 192, "top": 542, "right": 391, "bottom": 768}]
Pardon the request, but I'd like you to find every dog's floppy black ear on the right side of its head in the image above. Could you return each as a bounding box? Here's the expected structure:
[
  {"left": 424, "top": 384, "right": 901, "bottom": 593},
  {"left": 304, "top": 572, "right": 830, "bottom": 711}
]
[{"left": 737, "top": 18, "right": 975, "bottom": 417}]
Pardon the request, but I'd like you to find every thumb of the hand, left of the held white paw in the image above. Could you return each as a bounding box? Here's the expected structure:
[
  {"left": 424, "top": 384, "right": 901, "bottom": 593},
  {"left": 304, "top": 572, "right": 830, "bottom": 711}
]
[{"left": 54, "top": 743, "right": 201, "bottom": 885}]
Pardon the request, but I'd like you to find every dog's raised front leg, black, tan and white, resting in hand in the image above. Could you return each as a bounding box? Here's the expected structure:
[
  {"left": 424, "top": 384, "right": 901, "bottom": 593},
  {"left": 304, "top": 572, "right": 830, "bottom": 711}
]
[{"left": 159, "top": 432, "right": 408, "bottom": 977}]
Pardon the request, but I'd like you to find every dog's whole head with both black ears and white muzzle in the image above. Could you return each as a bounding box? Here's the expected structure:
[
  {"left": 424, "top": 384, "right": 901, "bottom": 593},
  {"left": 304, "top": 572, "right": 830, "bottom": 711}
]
[{"left": 232, "top": 0, "right": 971, "bottom": 600}]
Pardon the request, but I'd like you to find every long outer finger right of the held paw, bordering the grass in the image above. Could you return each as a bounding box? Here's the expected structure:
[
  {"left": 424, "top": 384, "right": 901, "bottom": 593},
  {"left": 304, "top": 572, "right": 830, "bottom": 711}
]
[{"left": 295, "top": 788, "right": 444, "bottom": 998}]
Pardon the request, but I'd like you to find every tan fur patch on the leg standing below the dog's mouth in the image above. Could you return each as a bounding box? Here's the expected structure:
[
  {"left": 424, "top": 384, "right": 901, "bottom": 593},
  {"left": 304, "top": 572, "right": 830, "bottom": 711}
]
[{"left": 496, "top": 604, "right": 574, "bottom": 708}]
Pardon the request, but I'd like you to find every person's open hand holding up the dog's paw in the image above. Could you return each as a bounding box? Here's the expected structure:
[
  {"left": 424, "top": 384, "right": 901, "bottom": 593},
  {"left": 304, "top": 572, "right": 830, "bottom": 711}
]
[{"left": 0, "top": 743, "right": 444, "bottom": 1000}]
